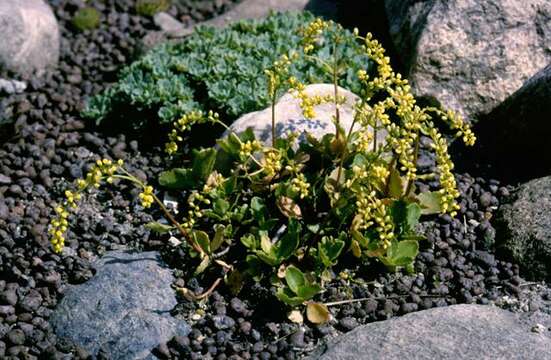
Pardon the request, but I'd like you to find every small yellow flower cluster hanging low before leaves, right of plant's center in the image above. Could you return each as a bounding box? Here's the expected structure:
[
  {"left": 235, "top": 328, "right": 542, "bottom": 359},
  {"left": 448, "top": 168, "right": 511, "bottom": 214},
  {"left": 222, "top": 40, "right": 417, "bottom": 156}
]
[{"left": 355, "top": 191, "right": 394, "bottom": 249}]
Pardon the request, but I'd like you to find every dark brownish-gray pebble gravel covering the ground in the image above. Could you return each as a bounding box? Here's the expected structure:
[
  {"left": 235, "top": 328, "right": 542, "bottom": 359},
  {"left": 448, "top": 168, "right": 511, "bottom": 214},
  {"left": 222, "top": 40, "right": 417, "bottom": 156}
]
[{"left": 0, "top": 0, "right": 551, "bottom": 359}]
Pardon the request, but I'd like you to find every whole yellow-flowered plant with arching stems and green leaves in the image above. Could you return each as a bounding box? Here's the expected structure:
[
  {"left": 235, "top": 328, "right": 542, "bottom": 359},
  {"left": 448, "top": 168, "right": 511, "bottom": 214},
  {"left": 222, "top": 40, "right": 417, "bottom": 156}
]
[{"left": 50, "top": 19, "right": 475, "bottom": 321}]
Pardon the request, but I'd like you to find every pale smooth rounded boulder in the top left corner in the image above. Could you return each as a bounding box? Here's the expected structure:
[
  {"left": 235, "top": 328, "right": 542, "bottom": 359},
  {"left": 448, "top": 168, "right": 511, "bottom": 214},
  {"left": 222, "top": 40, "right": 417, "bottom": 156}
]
[{"left": 0, "top": 0, "right": 60, "bottom": 74}]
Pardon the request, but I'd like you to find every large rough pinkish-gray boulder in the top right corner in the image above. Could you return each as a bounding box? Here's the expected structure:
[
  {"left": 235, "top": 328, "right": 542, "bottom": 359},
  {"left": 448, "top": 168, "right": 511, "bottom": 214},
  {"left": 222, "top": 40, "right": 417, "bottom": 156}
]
[{"left": 385, "top": 0, "right": 551, "bottom": 120}]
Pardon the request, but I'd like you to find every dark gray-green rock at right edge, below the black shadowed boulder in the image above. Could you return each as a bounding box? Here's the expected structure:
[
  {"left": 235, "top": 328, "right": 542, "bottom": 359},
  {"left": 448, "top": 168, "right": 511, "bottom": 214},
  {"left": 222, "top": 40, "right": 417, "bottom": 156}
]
[{"left": 494, "top": 177, "right": 551, "bottom": 280}]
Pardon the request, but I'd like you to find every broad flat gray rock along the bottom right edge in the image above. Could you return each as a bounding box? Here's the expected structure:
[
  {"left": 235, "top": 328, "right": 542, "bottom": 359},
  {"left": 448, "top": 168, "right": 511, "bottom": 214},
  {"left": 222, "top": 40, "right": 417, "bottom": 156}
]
[{"left": 310, "top": 305, "right": 551, "bottom": 360}]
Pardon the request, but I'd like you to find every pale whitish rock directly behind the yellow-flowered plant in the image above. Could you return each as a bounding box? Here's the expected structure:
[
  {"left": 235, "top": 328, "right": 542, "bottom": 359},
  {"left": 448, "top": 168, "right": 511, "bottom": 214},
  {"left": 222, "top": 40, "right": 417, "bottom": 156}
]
[{"left": 224, "top": 84, "right": 386, "bottom": 145}]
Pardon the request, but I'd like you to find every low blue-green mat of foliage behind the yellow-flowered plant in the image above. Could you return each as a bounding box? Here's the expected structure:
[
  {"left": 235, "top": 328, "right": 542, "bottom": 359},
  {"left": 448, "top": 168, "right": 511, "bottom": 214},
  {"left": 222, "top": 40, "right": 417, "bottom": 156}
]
[{"left": 83, "top": 13, "right": 368, "bottom": 128}]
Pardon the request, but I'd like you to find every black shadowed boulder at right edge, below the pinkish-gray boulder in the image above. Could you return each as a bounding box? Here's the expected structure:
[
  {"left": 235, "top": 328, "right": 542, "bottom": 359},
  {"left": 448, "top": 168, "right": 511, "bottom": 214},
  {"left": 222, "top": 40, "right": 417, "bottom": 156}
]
[{"left": 466, "top": 62, "right": 551, "bottom": 182}]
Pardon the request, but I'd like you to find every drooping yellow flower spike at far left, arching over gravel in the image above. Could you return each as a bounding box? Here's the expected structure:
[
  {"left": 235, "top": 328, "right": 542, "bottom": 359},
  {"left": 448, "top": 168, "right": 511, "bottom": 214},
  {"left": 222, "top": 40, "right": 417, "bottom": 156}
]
[{"left": 49, "top": 159, "right": 124, "bottom": 253}]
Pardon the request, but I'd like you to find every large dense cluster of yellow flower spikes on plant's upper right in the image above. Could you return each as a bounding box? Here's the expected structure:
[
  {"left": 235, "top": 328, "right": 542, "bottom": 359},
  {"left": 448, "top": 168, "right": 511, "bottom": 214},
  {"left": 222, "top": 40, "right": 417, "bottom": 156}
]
[{"left": 355, "top": 31, "right": 476, "bottom": 215}]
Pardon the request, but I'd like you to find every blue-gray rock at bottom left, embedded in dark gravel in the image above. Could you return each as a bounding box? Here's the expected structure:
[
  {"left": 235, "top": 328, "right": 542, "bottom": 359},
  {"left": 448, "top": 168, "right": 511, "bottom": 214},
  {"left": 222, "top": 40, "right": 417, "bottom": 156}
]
[{"left": 50, "top": 251, "right": 190, "bottom": 359}]
